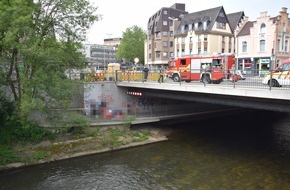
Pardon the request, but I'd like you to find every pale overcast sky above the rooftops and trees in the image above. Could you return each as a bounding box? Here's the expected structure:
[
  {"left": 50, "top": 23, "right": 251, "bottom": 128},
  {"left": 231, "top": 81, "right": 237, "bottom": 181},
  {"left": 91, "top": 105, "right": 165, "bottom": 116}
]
[{"left": 86, "top": 0, "right": 290, "bottom": 44}]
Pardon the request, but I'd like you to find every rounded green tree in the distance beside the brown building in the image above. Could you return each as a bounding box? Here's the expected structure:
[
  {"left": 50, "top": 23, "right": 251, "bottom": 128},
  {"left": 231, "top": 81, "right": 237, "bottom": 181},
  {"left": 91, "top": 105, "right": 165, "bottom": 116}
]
[{"left": 117, "top": 26, "right": 146, "bottom": 63}]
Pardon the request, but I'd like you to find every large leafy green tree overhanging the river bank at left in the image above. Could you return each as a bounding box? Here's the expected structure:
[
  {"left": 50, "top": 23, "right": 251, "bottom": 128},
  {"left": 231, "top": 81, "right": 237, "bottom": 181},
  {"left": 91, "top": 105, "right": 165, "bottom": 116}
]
[{"left": 0, "top": 0, "right": 99, "bottom": 124}]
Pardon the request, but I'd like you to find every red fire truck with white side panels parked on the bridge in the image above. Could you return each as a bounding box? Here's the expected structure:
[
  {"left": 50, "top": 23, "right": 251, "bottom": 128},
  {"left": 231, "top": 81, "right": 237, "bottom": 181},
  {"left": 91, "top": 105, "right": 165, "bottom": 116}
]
[{"left": 167, "top": 54, "right": 242, "bottom": 84}]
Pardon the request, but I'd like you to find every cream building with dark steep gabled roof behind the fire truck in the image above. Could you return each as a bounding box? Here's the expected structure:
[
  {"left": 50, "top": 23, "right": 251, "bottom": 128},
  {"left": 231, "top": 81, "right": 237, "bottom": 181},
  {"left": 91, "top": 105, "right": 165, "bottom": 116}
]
[{"left": 174, "top": 6, "right": 244, "bottom": 57}]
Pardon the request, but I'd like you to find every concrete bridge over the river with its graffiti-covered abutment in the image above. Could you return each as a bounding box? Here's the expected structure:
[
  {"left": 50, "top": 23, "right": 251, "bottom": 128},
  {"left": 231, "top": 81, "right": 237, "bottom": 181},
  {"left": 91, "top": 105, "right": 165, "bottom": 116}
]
[{"left": 84, "top": 77, "right": 290, "bottom": 123}]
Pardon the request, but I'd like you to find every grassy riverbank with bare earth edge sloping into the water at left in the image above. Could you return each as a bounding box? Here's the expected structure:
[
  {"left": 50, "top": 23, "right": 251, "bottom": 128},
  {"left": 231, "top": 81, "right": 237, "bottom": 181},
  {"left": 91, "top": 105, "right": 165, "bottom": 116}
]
[{"left": 0, "top": 126, "right": 168, "bottom": 170}]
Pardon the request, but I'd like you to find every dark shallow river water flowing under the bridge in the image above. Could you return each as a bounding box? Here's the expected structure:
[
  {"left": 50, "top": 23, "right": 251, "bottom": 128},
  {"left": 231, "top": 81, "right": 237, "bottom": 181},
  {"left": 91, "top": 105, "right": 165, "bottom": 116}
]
[{"left": 0, "top": 112, "right": 290, "bottom": 190}]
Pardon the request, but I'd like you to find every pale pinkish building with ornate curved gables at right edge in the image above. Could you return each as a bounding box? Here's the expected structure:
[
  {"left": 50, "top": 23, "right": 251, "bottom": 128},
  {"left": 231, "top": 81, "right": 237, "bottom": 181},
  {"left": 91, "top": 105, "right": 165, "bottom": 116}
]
[{"left": 235, "top": 7, "right": 290, "bottom": 75}]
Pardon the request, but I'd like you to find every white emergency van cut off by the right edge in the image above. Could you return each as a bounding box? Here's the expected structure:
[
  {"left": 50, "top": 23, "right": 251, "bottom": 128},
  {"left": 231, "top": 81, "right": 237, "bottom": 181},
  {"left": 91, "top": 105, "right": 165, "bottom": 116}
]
[{"left": 262, "top": 58, "right": 290, "bottom": 87}]
